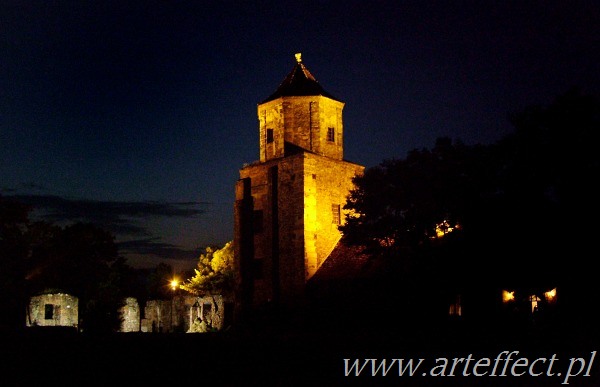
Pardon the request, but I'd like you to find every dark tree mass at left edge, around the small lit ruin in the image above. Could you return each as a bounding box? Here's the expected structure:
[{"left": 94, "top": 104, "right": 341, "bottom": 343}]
[{"left": 0, "top": 197, "right": 131, "bottom": 333}]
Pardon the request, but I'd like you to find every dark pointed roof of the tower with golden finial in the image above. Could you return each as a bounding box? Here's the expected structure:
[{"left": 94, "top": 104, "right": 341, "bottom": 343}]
[{"left": 261, "top": 53, "right": 342, "bottom": 103}]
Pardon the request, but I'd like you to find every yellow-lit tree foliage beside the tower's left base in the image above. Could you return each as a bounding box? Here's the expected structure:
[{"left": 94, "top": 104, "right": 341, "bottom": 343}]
[{"left": 180, "top": 241, "right": 234, "bottom": 296}]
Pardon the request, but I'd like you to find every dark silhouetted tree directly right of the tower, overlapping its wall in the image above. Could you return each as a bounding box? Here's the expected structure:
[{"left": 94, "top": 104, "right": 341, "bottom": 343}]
[{"left": 340, "top": 138, "right": 501, "bottom": 324}]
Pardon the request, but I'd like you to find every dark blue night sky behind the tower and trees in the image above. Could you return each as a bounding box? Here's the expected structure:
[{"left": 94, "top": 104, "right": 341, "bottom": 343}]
[{"left": 0, "top": 0, "right": 600, "bottom": 269}]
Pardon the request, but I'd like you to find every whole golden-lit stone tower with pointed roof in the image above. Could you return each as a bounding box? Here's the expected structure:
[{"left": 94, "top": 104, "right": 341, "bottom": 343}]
[{"left": 234, "top": 54, "right": 364, "bottom": 316}]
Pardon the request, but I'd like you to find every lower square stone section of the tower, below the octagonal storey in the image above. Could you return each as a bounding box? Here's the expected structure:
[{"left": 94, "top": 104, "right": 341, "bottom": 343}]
[{"left": 236, "top": 152, "right": 364, "bottom": 306}]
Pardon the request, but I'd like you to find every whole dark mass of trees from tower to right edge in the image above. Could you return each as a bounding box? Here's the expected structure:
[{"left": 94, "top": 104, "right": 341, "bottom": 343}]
[{"left": 340, "top": 90, "right": 600, "bottom": 316}]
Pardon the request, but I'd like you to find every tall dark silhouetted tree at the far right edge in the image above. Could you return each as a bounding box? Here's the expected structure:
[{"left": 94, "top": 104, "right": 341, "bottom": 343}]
[{"left": 501, "top": 88, "right": 600, "bottom": 320}]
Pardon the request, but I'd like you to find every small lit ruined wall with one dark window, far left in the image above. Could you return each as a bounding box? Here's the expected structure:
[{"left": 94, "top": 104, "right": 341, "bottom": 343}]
[{"left": 25, "top": 293, "right": 79, "bottom": 328}]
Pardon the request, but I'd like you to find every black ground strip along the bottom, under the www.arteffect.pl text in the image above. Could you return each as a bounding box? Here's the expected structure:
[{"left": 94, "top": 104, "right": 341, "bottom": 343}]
[{"left": 0, "top": 321, "right": 600, "bottom": 387}]
